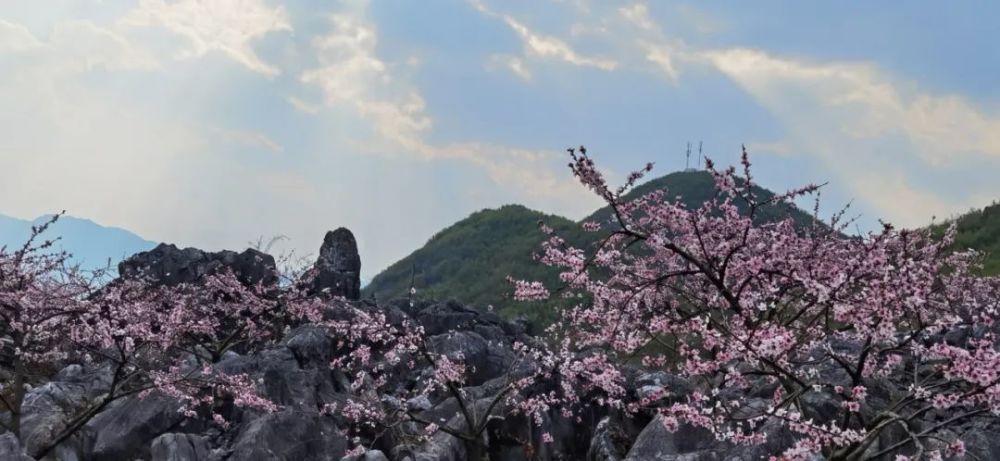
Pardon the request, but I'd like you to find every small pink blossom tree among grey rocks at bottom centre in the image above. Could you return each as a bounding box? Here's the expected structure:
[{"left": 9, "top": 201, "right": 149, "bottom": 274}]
[{"left": 315, "top": 292, "right": 535, "bottom": 460}]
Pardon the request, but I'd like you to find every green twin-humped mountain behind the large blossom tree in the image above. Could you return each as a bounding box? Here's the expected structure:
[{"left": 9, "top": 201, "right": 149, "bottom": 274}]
[{"left": 363, "top": 171, "right": 811, "bottom": 324}]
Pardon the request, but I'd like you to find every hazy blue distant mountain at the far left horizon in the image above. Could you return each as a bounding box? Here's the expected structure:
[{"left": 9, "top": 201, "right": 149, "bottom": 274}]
[{"left": 0, "top": 215, "right": 156, "bottom": 273}]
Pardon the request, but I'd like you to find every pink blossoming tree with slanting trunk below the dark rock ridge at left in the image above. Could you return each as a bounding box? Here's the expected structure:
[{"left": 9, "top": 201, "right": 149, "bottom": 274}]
[{"left": 26, "top": 274, "right": 286, "bottom": 457}]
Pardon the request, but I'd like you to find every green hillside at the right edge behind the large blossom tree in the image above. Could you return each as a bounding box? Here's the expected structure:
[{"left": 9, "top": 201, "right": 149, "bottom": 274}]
[{"left": 933, "top": 203, "right": 1000, "bottom": 275}]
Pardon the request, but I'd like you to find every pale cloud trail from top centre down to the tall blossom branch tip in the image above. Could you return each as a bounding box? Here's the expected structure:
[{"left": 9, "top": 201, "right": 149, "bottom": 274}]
[{"left": 293, "top": 13, "right": 593, "bottom": 215}]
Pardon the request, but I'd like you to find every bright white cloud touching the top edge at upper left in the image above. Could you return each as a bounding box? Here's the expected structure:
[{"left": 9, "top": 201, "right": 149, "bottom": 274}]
[{"left": 121, "top": 0, "right": 292, "bottom": 76}]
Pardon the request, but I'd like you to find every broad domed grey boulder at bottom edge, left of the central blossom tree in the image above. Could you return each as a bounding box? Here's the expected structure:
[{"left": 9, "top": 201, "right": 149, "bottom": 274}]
[{"left": 230, "top": 410, "right": 347, "bottom": 461}]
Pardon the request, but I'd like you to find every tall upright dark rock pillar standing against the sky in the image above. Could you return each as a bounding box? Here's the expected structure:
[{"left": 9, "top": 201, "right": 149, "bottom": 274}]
[{"left": 304, "top": 227, "right": 361, "bottom": 300}]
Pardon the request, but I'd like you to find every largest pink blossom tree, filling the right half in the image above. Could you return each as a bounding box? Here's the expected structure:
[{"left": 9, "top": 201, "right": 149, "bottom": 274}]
[{"left": 514, "top": 147, "right": 1000, "bottom": 460}]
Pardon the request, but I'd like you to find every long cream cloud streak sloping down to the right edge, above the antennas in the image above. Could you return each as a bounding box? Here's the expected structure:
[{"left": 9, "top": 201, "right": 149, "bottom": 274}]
[{"left": 704, "top": 49, "right": 1000, "bottom": 164}]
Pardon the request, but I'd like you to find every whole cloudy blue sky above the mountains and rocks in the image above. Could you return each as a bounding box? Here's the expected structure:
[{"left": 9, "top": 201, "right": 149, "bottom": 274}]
[{"left": 0, "top": 0, "right": 1000, "bottom": 278}]
